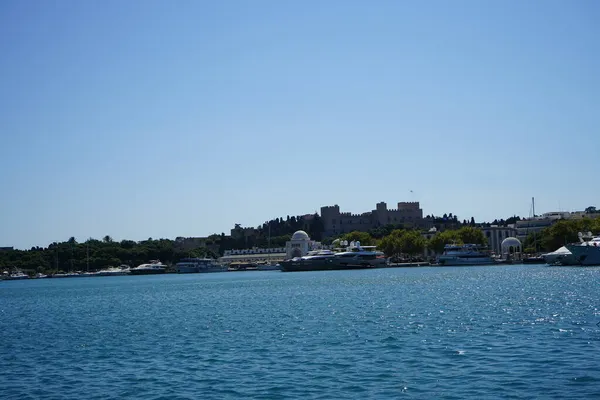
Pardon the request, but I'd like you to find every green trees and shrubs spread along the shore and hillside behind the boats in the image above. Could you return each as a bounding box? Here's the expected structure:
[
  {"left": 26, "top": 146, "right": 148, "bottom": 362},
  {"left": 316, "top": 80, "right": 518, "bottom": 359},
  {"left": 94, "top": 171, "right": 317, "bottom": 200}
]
[{"left": 0, "top": 207, "right": 600, "bottom": 273}]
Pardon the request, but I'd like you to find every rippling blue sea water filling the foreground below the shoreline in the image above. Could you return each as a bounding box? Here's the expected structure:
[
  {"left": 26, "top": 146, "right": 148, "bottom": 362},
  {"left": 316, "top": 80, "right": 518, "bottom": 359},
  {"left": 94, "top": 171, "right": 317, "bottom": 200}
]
[{"left": 0, "top": 266, "right": 600, "bottom": 399}]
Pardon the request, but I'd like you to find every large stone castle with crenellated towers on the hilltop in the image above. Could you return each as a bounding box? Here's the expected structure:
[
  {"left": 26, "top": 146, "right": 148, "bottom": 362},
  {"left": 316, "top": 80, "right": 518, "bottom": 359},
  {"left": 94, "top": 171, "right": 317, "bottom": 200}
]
[{"left": 321, "top": 201, "right": 423, "bottom": 236}]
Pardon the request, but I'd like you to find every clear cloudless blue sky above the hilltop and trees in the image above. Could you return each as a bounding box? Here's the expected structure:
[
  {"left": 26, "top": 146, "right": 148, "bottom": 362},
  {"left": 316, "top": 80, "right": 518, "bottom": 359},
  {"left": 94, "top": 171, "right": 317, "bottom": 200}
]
[{"left": 0, "top": 0, "right": 600, "bottom": 248}]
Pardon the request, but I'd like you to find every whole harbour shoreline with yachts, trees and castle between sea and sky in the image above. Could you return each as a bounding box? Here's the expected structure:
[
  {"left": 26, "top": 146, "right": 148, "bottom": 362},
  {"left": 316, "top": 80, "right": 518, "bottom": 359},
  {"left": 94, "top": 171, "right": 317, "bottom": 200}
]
[{"left": 0, "top": 199, "right": 600, "bottom": 280}]
